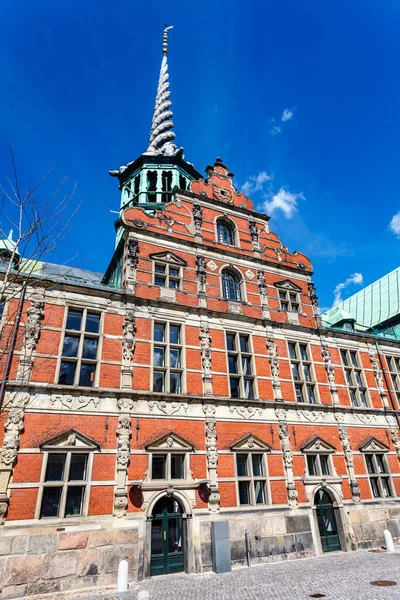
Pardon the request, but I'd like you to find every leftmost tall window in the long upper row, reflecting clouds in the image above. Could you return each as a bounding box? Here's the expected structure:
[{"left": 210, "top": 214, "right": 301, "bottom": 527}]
[{"left": 58, "top": 308, "right": 101, "bottom": 387}]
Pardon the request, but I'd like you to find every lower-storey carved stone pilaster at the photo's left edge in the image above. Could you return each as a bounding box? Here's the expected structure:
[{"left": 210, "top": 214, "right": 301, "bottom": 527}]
[{"left": 0, "top": 392, "right": 30, "bottom": 523}]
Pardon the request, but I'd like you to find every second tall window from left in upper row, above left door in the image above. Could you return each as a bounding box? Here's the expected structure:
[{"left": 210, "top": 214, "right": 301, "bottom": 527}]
[{"left": 153, "top": 323, "right": 182, "bottom": 394}]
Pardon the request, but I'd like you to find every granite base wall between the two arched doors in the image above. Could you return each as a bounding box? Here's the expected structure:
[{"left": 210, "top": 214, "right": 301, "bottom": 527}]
[{"left": 200, "top": 511, "right": 315, "bottom": 571}]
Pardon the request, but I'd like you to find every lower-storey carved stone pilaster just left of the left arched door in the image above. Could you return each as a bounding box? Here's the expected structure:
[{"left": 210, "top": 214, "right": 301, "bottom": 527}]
[{"left": 114, "top": 413, "right": 131, "bottom": 518}]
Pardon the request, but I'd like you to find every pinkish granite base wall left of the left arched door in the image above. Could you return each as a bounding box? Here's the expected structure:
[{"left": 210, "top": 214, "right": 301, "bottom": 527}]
[{"left": 0, "top": 527, "right": 139, "bottom": 599}]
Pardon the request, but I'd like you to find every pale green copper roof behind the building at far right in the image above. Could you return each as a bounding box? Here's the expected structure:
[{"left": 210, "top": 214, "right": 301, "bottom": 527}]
[{"left": 321, "top": 267, "right": 400, "bottom": 328}]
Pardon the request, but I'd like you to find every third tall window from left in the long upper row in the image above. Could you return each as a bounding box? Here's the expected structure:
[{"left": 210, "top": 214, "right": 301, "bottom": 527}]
[{"left": 226, "top": 333, "right": 254, "bottom": 399}]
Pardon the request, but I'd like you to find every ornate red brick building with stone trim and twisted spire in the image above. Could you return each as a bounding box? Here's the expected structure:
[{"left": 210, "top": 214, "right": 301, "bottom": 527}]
[{"left": 0, "top": 27, "right": 400, "bottom": 595}]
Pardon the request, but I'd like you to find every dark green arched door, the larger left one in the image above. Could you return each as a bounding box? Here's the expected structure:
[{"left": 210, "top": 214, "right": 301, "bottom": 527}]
[{"left": 150, "top": 496, "right": 185, "bottom": 575}]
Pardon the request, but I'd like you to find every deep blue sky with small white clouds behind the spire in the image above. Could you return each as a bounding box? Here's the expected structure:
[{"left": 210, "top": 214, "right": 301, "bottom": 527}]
[{"left": 0, "top": 0, "right": 400, "bottom": 307}]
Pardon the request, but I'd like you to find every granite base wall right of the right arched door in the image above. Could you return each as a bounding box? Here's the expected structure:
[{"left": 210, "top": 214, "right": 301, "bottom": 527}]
[{"left": 350, "top": 504, "right": 400, "bottom": 549}]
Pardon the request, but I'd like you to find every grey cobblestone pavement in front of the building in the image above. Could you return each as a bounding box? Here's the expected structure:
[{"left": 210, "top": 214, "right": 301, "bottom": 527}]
[{"left": 78, "top": 551, "right": 400, "bottom": 600}]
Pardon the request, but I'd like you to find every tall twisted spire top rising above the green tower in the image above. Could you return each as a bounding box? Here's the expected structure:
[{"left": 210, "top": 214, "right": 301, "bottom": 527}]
[{"left": 145, "top": 25, "right": 179, "bottom": 156}]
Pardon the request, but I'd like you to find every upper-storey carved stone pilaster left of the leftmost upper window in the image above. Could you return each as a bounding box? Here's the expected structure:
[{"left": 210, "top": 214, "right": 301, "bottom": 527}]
[{"left": 16, "top": 288, "right": 45, "bottom": 383}]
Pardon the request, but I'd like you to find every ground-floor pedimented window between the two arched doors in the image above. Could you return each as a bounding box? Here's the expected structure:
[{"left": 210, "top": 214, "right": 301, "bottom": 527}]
[{"left": 236, "top": 452, "right": 267, "bottom": 506}]
